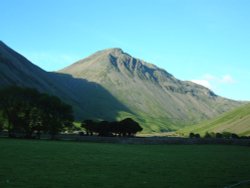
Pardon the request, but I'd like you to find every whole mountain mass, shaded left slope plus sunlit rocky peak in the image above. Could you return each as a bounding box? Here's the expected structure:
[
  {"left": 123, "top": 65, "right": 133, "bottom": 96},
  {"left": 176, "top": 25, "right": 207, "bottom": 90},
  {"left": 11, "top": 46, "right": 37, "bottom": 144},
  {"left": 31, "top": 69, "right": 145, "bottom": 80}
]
[{"left": 0, "top": 41, "right": 245, "bottom": 133}]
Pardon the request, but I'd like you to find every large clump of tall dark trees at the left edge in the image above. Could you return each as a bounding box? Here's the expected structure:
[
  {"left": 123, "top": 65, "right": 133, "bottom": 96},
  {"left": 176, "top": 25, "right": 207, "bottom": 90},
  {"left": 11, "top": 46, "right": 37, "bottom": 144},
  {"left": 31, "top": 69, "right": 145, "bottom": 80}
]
[{"left": 0, "top": 87, "right": 74, "bottom": 138}]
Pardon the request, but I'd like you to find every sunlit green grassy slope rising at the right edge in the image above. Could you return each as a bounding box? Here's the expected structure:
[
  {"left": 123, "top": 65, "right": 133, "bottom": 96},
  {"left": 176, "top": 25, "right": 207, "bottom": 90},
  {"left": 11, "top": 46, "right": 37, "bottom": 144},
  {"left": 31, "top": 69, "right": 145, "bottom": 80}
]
[{"left": 179, "top": 104, "right": 250, "bottom": 136}]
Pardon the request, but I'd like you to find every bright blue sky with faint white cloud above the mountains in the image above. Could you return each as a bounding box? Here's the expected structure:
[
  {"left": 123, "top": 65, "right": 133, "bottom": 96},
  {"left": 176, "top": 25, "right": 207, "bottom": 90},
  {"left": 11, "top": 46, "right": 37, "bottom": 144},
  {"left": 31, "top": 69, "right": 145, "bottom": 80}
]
[{"left": 0, "top": 0, "right": 250, "bottom": 100}]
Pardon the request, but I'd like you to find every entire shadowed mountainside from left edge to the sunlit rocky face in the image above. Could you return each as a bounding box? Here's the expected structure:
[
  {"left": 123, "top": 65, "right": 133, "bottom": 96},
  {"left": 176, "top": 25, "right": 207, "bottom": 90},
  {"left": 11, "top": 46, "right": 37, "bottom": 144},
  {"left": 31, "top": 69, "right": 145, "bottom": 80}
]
[{"left": 0, "top": 41, "right": 130, "bottom": 120}]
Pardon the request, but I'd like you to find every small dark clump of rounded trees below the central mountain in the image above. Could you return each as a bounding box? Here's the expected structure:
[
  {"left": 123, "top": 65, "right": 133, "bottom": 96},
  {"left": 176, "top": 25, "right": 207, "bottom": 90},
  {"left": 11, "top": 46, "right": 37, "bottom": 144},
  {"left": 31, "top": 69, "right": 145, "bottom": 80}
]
[{"left": 81, "top": 118, "right": 142, "bottom": 136}]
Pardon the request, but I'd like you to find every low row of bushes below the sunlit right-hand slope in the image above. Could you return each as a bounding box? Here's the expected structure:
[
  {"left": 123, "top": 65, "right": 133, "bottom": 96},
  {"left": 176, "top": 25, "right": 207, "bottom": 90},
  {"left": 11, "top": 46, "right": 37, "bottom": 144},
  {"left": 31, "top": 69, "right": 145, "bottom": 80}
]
[{"left": 189, "top": 132, "right": 249, "bottom": 139}]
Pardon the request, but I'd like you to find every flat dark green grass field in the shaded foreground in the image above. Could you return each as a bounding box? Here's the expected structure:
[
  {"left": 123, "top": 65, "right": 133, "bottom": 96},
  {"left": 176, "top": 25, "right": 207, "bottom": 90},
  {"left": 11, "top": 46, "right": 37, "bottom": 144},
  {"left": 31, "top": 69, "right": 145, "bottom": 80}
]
[{"left": 0, "top": 139, "right": 250, "bottom": 188}]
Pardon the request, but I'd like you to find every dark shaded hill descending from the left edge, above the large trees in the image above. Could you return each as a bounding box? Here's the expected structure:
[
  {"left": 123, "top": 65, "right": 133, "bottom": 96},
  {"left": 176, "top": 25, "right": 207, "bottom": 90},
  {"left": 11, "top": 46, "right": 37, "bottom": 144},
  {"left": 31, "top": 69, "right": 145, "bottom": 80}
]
[{"left": 0, "top": 41, "right": 56, "bottom": 92}]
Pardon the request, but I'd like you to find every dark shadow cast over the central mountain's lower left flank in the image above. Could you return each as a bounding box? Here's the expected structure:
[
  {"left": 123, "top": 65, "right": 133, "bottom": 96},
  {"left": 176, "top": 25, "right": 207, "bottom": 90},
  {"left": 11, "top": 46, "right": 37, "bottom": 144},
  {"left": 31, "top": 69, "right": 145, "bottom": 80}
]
[{"left": 50, "top": 73, "right": 133, "bottom": 120}]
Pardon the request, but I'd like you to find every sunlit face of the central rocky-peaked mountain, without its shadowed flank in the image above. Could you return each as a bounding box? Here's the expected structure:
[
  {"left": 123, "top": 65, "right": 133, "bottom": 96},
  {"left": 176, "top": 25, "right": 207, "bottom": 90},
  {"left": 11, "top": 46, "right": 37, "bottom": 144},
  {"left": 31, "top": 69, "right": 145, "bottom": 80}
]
[{"left": 58, "top": 48, "right": 241, "bottom": 132}]
